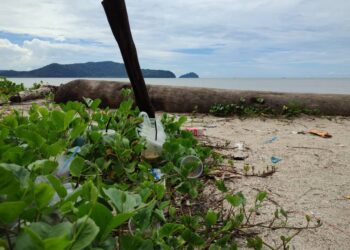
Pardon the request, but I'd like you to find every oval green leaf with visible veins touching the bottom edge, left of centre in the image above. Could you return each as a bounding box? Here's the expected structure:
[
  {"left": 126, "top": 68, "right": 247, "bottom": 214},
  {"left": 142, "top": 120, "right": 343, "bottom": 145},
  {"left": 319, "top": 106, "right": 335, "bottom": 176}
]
[{"left": 71, "top": 216, "right": 99, "bottom": 250}]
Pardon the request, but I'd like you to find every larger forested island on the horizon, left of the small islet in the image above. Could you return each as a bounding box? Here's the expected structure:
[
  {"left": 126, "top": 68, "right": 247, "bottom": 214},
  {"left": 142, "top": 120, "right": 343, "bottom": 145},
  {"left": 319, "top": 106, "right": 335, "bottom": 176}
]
[{"left": 0, "top": 61, "right": 176, "bottom": 78}]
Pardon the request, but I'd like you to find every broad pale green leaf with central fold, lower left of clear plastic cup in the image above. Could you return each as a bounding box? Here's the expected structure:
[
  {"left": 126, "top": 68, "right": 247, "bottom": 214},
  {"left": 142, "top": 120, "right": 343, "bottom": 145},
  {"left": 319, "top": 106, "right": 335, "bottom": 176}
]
[{"left": 103, "top": 188, "right": 142, "bottom": 213}]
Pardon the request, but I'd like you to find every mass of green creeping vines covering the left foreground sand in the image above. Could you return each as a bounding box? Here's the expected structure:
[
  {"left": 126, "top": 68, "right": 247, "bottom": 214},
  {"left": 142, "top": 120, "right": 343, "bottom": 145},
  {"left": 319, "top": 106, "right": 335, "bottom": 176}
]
[{"left": 0, "top": 91, "right": 320, "bottom": 250}]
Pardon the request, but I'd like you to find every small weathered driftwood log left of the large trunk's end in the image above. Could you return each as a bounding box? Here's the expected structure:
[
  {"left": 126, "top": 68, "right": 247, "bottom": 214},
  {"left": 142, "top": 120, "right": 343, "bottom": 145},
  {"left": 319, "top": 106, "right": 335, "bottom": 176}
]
[{"left": 9, "top": 85, "right": 58, "bottom": 102}]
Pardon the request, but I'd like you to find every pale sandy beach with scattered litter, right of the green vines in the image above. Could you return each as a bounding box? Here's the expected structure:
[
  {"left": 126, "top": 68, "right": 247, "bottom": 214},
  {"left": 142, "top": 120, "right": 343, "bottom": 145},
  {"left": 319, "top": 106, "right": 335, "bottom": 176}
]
[{"left": 183, "top": 114, "right": 350, "bottom": 249}]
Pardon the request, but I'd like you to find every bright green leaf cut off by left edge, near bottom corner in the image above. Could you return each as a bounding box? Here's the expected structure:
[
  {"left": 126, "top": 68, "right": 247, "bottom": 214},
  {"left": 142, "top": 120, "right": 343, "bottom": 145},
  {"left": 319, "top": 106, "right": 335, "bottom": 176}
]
[{"left": 0, "top": 201, "right": 26, "bottom": 223}]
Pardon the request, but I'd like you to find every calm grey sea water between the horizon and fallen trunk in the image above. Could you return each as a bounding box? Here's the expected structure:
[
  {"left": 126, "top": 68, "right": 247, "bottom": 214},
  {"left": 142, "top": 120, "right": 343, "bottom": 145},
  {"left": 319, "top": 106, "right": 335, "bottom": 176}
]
[{"left": 9, "top": 78, "right": 350, "bottom": 94}]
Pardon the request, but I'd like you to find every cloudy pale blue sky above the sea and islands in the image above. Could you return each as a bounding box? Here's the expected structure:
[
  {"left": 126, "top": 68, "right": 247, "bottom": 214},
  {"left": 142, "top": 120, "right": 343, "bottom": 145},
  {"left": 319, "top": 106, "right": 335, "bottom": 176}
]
[{"left": 0, "top": 0, "right": 350, "bottom": 77}]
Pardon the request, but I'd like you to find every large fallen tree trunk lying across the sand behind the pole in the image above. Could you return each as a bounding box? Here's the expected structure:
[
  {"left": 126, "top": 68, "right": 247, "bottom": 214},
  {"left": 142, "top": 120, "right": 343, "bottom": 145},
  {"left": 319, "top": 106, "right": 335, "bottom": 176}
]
[{"left": 55, "top": 80, "right": 350, "bottom": 116}]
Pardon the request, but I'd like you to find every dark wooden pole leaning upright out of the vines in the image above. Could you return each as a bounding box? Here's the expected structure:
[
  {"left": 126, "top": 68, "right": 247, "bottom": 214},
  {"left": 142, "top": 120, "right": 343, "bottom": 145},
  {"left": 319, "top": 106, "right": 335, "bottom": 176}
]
[{"left": 102, "top": 0, "right": 155, "bottom": 118}]
